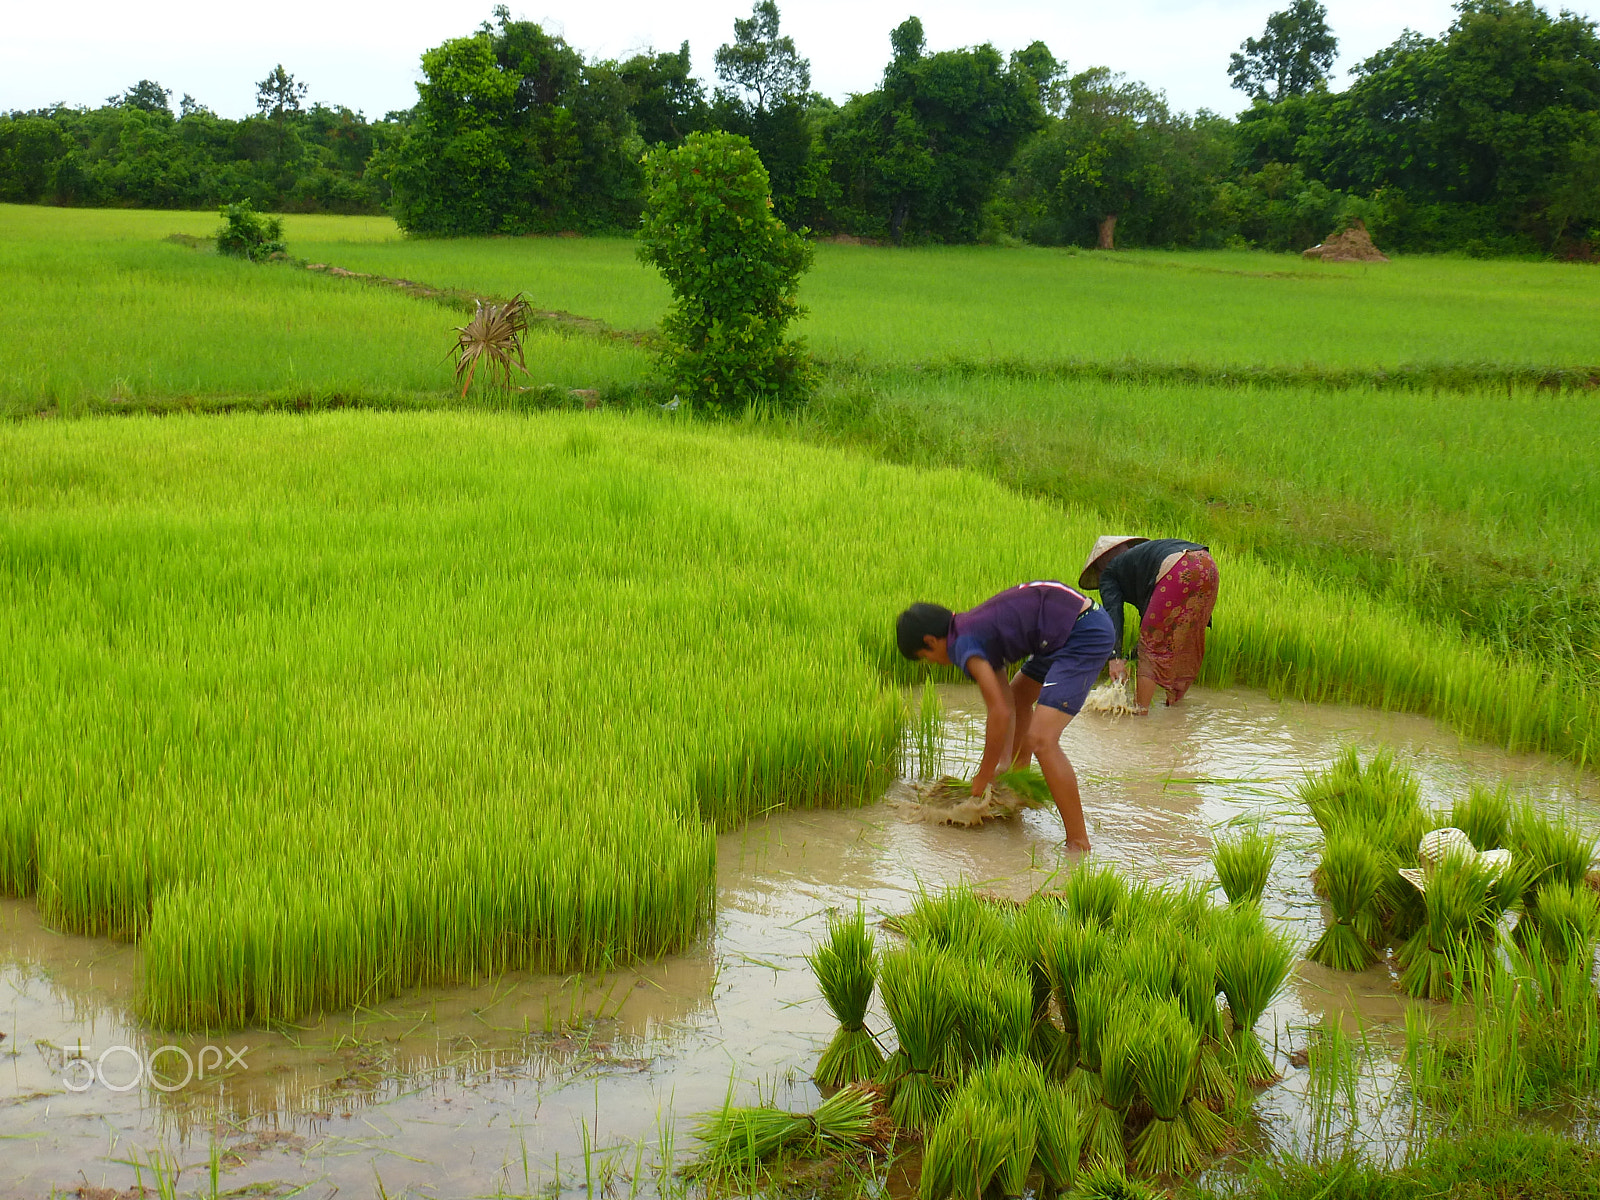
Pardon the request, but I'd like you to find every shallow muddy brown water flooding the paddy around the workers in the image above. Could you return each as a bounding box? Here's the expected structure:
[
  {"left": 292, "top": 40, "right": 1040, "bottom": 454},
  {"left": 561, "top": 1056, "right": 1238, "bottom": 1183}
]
[{"left": 0, "top": 688, "right": 1600, "bottom": 1197}]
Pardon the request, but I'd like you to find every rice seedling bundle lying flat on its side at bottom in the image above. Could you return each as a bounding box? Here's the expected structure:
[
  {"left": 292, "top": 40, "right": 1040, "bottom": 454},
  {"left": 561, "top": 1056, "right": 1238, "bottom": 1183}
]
[{"left": 686, "top": 1088, "right": 874, "bottom": 1179}]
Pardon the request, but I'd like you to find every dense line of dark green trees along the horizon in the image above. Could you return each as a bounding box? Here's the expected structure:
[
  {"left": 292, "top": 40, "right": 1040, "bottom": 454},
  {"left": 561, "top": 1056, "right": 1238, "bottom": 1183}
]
[{"left": 0, "top": 0, "right": 1600, "bottom": 253}]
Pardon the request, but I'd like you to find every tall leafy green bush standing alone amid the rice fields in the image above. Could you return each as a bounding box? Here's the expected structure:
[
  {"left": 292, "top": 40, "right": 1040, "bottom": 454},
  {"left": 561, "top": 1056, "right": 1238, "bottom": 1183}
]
[{"left": 638, "top": 133, "right": 813, "bottom": 410}]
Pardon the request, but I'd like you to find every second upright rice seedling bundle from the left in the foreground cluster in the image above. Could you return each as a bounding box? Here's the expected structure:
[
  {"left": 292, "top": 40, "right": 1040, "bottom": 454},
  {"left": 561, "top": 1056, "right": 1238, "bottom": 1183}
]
[{"left": 878, "top": 944, "right": 955, "bottom": 1130}]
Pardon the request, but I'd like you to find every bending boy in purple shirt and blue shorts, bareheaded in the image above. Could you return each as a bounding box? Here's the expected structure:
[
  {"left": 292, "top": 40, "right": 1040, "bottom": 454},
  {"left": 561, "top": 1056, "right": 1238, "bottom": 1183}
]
[{"left": 894, "top": 579, "right": 1114, "bottom": 850}]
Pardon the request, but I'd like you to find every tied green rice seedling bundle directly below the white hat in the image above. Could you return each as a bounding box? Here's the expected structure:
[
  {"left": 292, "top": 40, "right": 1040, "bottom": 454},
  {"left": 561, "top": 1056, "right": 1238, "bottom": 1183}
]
[{"left": 1400, "top": 854, "right": 1510, "bottom": 1000}]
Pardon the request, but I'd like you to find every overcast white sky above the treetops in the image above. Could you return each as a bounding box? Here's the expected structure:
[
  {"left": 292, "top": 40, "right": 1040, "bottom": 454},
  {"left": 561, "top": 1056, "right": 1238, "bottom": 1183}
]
[{"left": 0, "top": 0, "right": 1600, "bottom": 117}]
